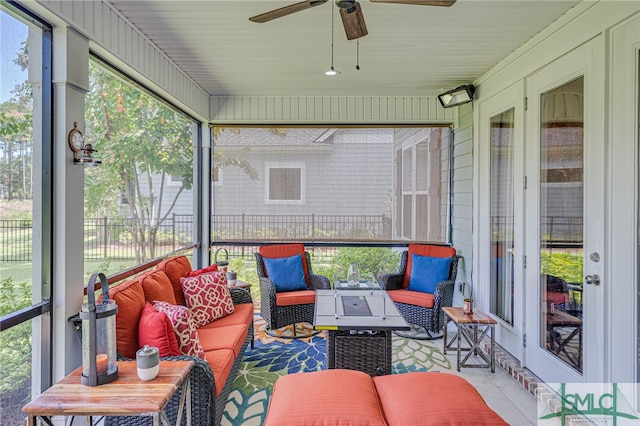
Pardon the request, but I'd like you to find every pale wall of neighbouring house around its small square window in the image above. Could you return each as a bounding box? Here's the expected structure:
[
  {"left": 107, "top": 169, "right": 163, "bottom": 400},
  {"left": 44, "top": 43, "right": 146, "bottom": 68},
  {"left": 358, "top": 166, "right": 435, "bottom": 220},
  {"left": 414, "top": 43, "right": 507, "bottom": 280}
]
[{"left": 214, "top": 128, "right": 393, "bottom": 220}]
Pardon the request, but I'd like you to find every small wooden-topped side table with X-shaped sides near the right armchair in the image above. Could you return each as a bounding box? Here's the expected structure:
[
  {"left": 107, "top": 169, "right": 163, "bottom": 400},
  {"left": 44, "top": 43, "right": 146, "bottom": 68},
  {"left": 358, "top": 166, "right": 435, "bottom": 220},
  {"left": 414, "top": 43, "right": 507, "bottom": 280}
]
[{"left": 442, "top": 307, "right": 496, "bottom": 373}]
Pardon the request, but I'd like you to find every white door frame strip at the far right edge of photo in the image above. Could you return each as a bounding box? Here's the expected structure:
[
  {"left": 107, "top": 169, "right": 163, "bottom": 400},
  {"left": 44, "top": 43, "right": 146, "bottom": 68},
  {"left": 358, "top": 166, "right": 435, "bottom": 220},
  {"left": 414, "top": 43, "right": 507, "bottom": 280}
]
[{"left": 605, "top": 16, "right": 640, "bottom": 383}]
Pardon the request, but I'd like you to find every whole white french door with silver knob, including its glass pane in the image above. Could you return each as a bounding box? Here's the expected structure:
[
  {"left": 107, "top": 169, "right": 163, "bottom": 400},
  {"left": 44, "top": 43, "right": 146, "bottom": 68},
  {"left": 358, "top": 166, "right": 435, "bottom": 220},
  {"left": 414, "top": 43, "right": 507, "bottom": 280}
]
[{"left": 523, "top": 40, "right": 608, "bottom": 383}]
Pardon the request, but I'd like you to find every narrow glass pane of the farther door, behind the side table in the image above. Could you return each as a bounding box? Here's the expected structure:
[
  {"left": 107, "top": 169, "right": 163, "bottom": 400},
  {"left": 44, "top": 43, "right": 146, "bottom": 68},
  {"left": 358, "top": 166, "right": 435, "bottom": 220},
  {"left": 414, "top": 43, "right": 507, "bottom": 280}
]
[{"left": 489, "top": 108, "right": 515, "bottom": 324}]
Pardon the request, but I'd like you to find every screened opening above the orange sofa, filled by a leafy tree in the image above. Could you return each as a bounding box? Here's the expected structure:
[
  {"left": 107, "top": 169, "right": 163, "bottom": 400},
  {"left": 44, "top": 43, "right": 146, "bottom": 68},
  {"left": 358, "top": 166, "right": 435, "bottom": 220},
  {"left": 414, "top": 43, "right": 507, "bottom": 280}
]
[{"left": 84, "top": 58, "right": 197, "bottom": 275}]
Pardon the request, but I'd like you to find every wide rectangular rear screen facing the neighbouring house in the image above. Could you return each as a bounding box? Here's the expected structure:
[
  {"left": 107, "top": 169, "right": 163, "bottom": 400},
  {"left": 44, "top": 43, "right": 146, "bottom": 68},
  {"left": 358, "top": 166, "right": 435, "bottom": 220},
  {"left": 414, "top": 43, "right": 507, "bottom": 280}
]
[{"left": 212, "top": 126, "right": 451, "bottom": 243}]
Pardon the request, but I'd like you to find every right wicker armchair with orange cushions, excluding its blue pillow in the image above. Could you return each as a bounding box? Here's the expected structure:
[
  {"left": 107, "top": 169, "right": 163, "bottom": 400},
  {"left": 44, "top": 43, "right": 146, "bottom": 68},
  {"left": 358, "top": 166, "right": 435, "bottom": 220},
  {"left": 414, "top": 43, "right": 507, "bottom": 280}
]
[{"left": 380, "top": 244, "right": 460, "bottom": 339}]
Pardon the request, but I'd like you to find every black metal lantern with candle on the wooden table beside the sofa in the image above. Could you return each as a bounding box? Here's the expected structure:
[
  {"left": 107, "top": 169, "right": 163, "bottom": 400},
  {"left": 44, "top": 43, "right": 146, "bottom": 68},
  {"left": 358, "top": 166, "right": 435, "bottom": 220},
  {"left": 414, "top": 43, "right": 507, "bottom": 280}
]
[{"left": 80, "top": 273, "right": 118, "bottom": 386}]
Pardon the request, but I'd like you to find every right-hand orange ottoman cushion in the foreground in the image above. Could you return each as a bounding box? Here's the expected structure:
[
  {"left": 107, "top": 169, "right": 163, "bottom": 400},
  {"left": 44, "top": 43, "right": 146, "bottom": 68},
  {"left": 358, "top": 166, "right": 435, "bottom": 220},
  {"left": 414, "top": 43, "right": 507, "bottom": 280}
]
[{"left": 372, "top": 372, "right": 507, "bottom": 426}]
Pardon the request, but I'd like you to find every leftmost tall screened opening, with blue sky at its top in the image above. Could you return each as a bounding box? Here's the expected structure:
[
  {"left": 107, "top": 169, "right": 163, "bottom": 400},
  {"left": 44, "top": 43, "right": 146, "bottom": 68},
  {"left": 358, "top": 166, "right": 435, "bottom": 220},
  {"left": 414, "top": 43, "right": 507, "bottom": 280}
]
[{"left": 0, "top": 2, "right": 53, "bottom": 426}]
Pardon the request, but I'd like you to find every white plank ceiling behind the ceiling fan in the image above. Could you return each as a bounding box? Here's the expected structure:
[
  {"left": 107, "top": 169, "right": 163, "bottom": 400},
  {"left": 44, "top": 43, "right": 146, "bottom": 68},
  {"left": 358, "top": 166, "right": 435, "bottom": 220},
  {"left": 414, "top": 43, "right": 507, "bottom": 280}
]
[{"left": 111, "top": 0, "right": 578, "bottom": 96}]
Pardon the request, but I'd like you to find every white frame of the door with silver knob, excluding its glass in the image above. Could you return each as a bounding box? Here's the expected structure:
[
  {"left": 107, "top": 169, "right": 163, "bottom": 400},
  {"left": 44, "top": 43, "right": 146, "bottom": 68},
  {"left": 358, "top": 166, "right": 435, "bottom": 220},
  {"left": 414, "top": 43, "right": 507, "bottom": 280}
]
[{"left": 524, "top": 36, "right": 611, "bottom": 383}]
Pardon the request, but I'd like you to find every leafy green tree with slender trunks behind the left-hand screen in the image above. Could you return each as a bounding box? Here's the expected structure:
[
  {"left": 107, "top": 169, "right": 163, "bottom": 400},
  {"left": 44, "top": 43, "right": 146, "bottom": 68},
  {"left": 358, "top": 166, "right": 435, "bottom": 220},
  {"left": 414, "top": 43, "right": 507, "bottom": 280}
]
[{"left": 85, "top": 63, "right": 193, "bottom": 262}]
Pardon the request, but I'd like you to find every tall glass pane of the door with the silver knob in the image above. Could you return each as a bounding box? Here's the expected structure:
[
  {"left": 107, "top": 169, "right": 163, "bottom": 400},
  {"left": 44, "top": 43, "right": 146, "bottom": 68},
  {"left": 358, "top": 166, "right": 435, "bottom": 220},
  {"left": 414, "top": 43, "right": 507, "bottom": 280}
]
[{"left": 540, "top": 78, "right": 584, "bottom": 372}]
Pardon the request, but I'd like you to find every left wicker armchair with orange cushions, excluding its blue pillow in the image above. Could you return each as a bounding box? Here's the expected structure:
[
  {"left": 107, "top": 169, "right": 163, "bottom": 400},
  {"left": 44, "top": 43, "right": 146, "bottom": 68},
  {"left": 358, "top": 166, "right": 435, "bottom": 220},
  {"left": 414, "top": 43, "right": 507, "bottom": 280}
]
[{"left": 255, "top": 244, "right": 330, "bottom": 337}]
